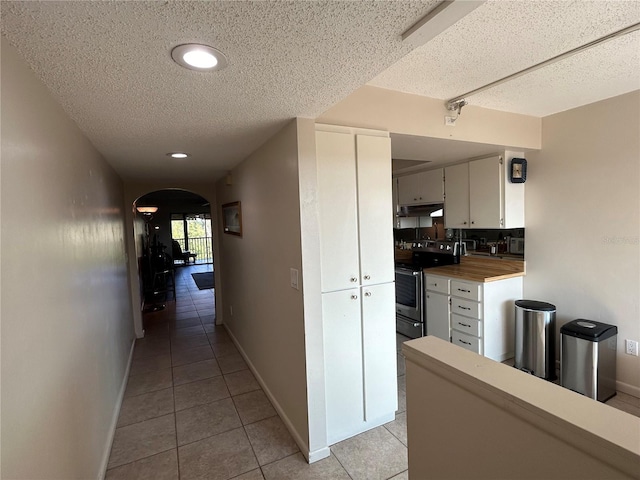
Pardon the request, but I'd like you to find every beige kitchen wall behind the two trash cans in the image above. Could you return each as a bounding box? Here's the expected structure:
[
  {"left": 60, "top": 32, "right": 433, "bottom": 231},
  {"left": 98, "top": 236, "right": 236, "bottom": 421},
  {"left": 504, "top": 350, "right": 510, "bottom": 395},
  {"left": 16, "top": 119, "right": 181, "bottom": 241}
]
[{"left": 524, "top": 91, "right": 640, "bottom": 396}]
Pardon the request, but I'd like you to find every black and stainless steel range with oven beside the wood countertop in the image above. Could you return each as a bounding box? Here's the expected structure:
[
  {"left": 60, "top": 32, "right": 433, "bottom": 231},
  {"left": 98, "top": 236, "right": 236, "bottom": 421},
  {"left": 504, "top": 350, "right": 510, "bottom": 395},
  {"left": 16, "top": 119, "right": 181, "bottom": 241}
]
[{"left": 395, "top": 240, "right": 464, "bottom": 338}]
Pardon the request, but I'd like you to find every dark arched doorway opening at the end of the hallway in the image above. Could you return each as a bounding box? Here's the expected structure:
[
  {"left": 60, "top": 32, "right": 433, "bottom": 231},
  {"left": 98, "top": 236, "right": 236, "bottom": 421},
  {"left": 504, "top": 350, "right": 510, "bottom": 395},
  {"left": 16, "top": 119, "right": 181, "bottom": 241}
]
[{"left": 132, "top": 189, "right": 215, "bottom": 333}]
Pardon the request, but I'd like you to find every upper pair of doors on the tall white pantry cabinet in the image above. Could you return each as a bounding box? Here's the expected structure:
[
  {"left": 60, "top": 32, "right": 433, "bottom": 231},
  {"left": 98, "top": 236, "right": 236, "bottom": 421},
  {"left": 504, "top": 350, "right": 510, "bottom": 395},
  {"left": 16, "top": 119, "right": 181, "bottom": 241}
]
[{"left": 316, "top": 131, "right": 394, "bottom": 292}]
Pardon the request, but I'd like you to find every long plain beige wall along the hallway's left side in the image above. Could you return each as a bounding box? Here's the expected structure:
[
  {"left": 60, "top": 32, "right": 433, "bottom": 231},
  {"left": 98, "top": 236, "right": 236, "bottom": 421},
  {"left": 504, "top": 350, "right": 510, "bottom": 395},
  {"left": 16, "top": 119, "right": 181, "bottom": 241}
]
[{"left": 1, "top": 40, "right": 134, "bottom": 479}]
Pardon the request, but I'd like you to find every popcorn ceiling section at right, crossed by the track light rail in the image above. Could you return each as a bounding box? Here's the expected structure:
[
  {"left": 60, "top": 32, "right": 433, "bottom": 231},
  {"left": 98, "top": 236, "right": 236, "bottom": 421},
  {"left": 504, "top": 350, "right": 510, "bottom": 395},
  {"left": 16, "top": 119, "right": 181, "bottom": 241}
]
[{"left": 369, "top": 0, "right": 640, "bottom": 117}]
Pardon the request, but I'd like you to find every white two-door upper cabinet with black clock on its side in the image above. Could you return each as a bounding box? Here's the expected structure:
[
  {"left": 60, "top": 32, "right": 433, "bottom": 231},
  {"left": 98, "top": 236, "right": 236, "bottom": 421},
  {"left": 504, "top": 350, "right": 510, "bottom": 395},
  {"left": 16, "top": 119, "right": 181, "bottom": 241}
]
[{"left": 445, "top": 152, "right": 524, "bottom": 228}]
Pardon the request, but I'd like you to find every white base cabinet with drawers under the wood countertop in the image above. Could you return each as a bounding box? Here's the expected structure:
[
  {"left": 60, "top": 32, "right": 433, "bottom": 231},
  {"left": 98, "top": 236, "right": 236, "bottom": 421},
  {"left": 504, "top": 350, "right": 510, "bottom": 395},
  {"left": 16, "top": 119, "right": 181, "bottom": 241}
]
[{"left": 426, "top": 274, "right": 522, "bottom": 362}]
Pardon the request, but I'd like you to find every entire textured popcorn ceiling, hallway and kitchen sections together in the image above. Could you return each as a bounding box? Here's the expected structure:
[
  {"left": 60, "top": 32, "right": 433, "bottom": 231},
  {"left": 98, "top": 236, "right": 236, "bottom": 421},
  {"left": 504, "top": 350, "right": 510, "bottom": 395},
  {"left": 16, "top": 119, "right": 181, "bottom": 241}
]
[{"left": 0, "top": 0, "right": 640, "bottom": 181}]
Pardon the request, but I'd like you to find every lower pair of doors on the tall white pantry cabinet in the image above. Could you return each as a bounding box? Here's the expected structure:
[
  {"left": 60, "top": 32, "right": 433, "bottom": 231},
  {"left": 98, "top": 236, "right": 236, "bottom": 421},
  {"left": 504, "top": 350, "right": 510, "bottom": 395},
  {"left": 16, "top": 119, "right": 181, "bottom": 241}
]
[{"left": 322, "top": 282, "right": 398, "bottom": 445}]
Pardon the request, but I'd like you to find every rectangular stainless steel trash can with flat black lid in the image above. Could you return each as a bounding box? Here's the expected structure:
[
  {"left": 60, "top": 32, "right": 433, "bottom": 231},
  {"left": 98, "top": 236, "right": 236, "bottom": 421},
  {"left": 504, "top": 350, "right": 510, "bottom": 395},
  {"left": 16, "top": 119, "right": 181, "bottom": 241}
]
[{"left": 560, "top": 318, "right": 618, "bottom": 402}]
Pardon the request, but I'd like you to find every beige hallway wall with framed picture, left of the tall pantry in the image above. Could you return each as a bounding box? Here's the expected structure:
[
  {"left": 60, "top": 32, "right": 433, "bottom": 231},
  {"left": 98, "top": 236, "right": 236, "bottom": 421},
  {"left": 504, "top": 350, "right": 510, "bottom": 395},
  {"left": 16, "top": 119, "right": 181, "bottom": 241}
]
[{"left": 216, "top": 120, "right": 309, "bottom": 454}]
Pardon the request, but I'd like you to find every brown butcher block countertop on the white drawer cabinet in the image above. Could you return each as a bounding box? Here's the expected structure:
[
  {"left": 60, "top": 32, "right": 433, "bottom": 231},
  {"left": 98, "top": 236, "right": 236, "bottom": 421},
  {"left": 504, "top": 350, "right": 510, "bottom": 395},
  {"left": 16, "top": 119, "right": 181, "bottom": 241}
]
[{"left": 424, "top": 256, "right": 525, "bottom": 283}]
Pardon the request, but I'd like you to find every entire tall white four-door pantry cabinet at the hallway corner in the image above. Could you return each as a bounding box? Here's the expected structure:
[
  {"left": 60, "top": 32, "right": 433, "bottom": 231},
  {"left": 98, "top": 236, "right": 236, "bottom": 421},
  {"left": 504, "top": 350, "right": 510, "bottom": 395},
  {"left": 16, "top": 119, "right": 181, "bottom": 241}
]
[{"left": 316, "top": 125, "right": 397, "bottom": 445}]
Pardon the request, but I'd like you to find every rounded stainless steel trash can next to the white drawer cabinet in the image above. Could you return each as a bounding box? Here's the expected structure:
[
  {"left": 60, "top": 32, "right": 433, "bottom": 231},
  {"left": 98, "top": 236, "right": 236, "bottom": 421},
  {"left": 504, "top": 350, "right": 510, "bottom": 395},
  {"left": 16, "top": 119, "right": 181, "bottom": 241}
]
[{"left": 514, "top": 300, "right": 556, "bottom": 380}]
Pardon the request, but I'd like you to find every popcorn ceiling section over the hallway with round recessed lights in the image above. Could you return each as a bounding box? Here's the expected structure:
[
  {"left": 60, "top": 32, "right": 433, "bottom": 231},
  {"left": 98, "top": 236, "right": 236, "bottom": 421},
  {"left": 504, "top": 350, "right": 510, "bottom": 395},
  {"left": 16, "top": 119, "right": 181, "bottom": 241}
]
[{"left": 1, "top": 0, "right": 438, "bottom": 180}]
